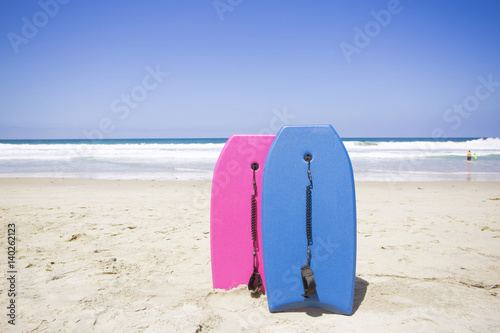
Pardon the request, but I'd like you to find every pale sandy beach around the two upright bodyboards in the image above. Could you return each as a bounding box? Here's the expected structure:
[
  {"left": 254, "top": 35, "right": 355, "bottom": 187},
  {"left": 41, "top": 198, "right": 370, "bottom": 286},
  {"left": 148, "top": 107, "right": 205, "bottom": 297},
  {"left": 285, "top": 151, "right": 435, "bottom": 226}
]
[{"left": 0, "top": 179, "right": 500, "bottom": 332}]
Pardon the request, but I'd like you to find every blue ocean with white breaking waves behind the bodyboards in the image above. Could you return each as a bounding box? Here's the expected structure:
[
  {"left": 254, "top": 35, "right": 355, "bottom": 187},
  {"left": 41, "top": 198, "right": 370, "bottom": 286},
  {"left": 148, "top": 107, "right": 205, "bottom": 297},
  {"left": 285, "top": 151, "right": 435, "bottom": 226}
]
[{"left": 0, "top": 138, "right": 500, "bottom": 181}]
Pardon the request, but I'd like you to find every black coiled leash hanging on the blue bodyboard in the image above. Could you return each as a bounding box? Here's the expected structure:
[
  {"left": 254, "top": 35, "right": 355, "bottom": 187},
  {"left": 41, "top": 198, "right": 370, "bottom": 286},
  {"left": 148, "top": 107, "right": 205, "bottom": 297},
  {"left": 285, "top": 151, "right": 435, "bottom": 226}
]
[{"left": 301, "top": 154, "right": 316, "bottom": 298}]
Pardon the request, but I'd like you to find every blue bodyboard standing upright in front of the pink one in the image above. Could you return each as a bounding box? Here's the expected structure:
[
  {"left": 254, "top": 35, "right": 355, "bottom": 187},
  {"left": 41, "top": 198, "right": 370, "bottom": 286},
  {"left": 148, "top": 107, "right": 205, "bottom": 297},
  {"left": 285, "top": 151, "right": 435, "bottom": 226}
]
[{"left": 261, "top": 125, "right": 356, "bottom": 315}]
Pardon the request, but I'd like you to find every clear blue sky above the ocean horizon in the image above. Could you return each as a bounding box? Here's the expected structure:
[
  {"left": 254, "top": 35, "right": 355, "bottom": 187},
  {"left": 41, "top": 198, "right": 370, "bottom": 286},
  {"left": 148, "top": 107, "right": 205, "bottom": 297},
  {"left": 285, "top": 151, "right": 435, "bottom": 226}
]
[{"left": 0, "top": 0, "right": 500, "bottom": 139}]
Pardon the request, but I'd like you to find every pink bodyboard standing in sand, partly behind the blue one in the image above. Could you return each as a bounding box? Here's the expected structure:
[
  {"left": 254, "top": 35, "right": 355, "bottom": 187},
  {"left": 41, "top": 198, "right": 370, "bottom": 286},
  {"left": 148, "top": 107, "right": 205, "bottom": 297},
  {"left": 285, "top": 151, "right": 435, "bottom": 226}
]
[{"left": 210, "top": 134, "right": 275, "bottom": 290}]
